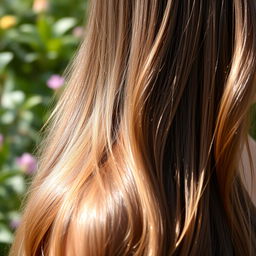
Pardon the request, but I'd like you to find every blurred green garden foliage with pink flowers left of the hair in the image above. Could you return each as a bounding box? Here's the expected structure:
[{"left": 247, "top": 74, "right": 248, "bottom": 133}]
[{"left": 0, "top": 0, "right": 87, "bottom": 256}]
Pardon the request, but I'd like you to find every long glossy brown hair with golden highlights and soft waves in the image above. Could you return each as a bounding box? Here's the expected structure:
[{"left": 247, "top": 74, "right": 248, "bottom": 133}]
[{"left": 10, "top": 0, "right": 256, "bottom": 256}]
